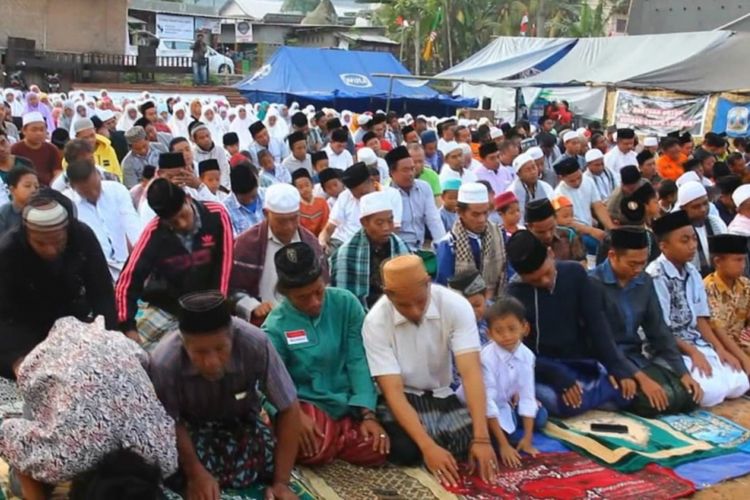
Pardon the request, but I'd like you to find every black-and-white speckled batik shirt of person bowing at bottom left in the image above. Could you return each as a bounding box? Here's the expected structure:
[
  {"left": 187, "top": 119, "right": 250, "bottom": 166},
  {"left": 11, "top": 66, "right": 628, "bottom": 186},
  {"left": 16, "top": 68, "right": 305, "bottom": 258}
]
[{"left": 0, "top": 317, "right": 177, "bottom": 484}]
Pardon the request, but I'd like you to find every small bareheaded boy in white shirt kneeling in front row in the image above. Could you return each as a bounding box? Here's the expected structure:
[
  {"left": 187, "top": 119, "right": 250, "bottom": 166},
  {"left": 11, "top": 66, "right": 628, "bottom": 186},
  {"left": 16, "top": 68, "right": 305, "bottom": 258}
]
[{"left": 457, "top": 297, "right": 547, "bottom": 467}]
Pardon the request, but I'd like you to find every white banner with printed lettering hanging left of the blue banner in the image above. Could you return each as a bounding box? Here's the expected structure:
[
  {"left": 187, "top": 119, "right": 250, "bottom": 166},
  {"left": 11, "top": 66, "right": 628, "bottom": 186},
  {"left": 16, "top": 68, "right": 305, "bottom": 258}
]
[{"left": 615, "top": 90, "right": 708, "bottom": 136}]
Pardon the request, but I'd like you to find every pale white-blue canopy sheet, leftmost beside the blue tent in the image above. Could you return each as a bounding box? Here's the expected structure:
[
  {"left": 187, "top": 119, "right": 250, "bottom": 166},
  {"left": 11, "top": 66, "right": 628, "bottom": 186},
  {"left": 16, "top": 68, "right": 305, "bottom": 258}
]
[{"left": 437, "top": 36, "right": 577, "bottom": 81}]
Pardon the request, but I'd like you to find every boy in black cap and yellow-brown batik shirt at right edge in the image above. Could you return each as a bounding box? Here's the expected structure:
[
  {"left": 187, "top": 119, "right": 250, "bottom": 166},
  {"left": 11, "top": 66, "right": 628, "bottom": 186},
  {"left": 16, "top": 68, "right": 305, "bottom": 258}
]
[{"left": 703, "top": 234, "right": 750, "bottom": 364}]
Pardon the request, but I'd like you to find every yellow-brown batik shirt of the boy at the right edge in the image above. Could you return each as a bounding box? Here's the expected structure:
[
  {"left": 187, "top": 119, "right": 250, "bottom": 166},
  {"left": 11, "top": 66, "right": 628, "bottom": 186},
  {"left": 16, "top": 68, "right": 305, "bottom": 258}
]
[{"left": 703, "top": 273, "right": 750, "bottom": 354}]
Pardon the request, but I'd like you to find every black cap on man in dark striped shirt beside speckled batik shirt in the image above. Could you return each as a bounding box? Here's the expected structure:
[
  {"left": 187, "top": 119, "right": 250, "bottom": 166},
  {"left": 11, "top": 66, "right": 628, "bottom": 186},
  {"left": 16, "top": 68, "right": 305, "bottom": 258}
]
[{"left": 179, "top": 290, "right": 232, "bottom": 335}]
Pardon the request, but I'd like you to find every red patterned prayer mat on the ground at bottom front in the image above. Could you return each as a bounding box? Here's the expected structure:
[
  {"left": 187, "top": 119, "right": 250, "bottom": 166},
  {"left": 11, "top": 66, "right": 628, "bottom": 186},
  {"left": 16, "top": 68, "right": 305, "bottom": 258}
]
[{"left": 450, "top": 452, "right": 695, "bottom": 500}]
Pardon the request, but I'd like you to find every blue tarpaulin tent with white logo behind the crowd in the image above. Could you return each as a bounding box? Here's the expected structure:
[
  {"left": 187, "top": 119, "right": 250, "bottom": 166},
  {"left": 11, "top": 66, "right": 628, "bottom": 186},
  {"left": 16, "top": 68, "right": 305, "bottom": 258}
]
[{"left": 235, "top": 47, "right": 477, "bottom": 116}]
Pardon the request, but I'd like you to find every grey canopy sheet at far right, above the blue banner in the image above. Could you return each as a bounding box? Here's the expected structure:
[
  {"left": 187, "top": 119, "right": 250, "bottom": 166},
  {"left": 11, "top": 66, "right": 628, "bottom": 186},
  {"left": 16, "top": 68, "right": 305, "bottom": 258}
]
[{"left": 623, "top": 33, "right": 750, "bottom": 94}]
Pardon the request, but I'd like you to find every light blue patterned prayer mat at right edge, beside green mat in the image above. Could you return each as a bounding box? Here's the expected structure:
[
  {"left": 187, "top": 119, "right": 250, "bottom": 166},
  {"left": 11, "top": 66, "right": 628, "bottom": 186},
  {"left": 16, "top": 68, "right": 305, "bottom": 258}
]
[{"left": 659, "top": 410, "right": 750, "bottom": 454}]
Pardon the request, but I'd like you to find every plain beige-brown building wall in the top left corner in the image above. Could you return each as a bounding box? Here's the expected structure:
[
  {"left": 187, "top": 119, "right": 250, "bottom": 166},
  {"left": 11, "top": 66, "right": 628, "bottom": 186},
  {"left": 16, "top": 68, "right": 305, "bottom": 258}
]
[{"left": 0, "top": 0, "right": 127, "bottom": 54}]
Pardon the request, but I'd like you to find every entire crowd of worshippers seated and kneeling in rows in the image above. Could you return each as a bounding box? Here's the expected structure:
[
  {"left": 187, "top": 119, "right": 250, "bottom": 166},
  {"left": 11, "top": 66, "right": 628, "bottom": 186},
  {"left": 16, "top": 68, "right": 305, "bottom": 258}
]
[{"left": 0, "top": 84, "right": 750, "bottom": 499}]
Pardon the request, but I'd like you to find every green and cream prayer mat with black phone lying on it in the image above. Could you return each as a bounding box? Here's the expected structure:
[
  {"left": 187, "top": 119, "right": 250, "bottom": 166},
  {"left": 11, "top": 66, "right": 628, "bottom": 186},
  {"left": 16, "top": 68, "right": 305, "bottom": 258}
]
[{"left": 543, "top": 410, "right": 731, "bottom": 472}]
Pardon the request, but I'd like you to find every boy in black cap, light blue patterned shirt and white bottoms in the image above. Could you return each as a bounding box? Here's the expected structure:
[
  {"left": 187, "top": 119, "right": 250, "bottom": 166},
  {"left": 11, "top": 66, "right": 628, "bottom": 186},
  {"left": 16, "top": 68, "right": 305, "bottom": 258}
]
[{"left": 646, "top": 210, "right": 750, "bottom": 406}]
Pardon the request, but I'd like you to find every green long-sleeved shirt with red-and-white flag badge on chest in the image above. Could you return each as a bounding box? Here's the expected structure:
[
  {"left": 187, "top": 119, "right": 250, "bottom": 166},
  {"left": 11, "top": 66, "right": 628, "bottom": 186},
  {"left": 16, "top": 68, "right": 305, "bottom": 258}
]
[{"left": 263, "top": 287, "right": 377, "bottom": 419}]
